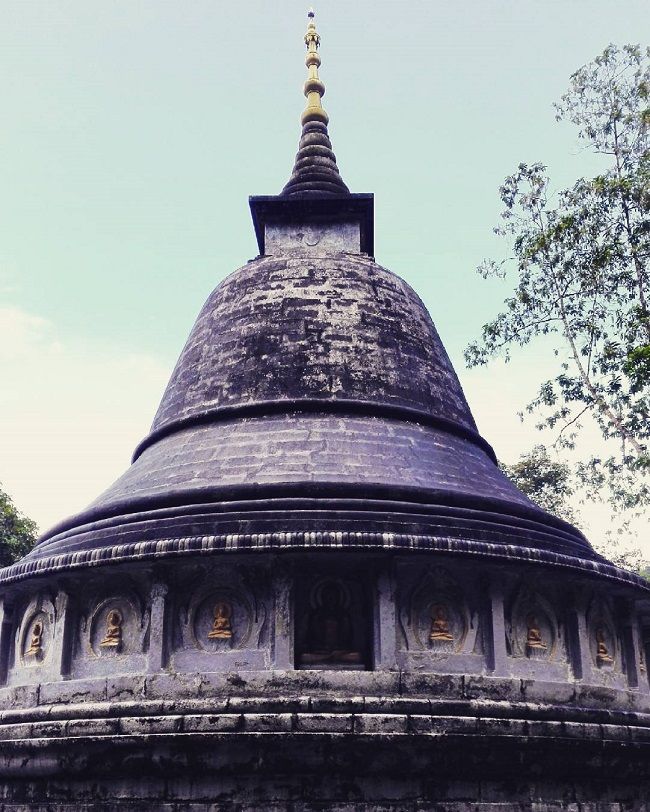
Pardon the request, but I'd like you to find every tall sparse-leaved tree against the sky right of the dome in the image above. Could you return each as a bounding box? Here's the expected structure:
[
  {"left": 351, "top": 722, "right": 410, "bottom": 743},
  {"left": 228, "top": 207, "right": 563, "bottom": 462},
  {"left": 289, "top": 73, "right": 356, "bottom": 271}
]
[{"left": 465, "top": 45, "right": 650, "bottom": 536}]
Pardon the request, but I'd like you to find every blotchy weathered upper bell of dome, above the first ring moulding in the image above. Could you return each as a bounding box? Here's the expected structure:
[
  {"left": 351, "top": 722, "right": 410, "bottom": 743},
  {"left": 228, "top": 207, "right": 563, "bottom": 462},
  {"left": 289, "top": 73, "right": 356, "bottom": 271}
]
[{"left": 148, "top": 253, "right": 476, "bottom": 430}]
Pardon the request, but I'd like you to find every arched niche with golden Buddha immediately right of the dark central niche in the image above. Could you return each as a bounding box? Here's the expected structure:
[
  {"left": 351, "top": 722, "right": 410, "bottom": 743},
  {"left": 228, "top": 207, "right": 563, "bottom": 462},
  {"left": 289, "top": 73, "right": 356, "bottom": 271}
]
[{"left": 400, "top": 567, "right": 478, "bottom": 655}]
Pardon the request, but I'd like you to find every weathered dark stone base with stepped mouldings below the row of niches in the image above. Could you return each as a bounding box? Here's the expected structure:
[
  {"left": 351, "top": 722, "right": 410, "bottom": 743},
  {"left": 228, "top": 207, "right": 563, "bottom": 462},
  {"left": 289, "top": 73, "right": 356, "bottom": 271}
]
[{"left": 0, "top": 671, "right": 650, "bottom": 812}]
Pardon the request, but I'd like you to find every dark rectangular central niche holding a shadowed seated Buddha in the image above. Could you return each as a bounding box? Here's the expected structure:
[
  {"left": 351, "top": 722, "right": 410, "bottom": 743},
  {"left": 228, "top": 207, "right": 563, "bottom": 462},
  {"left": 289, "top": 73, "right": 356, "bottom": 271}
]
[{"left": 295, "top": 576, "right": 370, "bottom": 671}]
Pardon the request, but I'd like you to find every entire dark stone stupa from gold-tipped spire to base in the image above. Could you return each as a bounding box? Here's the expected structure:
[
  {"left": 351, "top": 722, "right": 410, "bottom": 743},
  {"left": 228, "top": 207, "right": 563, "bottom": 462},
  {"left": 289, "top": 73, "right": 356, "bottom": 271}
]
[{"left": 0, "top": 13, "right": 650, "bottom": 812}]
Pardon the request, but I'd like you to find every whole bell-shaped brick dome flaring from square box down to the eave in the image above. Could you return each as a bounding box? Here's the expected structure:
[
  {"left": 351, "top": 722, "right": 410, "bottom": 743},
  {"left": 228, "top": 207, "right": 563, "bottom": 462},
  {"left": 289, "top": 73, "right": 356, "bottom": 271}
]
[{"left": 12, "top": 246, "right": 604, "bottom": 578}]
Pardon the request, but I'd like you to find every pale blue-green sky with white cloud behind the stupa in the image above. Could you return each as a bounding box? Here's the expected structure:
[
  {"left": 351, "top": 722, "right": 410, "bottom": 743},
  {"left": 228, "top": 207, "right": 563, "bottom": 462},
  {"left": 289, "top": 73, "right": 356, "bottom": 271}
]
[{"left": 0, "top": 0, "right": 650, "bottom": 557}]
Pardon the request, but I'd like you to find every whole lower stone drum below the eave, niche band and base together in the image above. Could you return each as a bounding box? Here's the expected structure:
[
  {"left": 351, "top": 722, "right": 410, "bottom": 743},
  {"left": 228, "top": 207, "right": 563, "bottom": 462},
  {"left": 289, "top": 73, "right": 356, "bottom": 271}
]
[{"left": 0, "top": 550, "right": 650, "bottom": 812}]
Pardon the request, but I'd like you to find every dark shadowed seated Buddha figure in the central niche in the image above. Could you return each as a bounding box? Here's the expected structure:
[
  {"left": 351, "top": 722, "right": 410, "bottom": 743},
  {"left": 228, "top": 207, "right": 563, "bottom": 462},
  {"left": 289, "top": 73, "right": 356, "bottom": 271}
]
[{"left": 299, "top": 582, "right": 362, "bottom": 665}]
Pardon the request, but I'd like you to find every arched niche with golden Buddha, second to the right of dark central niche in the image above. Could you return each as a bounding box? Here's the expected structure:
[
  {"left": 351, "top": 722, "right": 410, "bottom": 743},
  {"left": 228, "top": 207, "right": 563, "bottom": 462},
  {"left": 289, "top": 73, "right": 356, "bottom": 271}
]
[{"left": 507, "top": 585, "right": 563, "bottom": 660}]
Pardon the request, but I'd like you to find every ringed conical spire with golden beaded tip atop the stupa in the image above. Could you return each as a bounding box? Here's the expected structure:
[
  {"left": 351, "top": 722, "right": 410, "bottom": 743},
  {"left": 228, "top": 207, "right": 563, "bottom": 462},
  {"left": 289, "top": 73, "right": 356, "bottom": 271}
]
[{"left": 281, "top": 10, "right": 350, "bottom": 196}]
